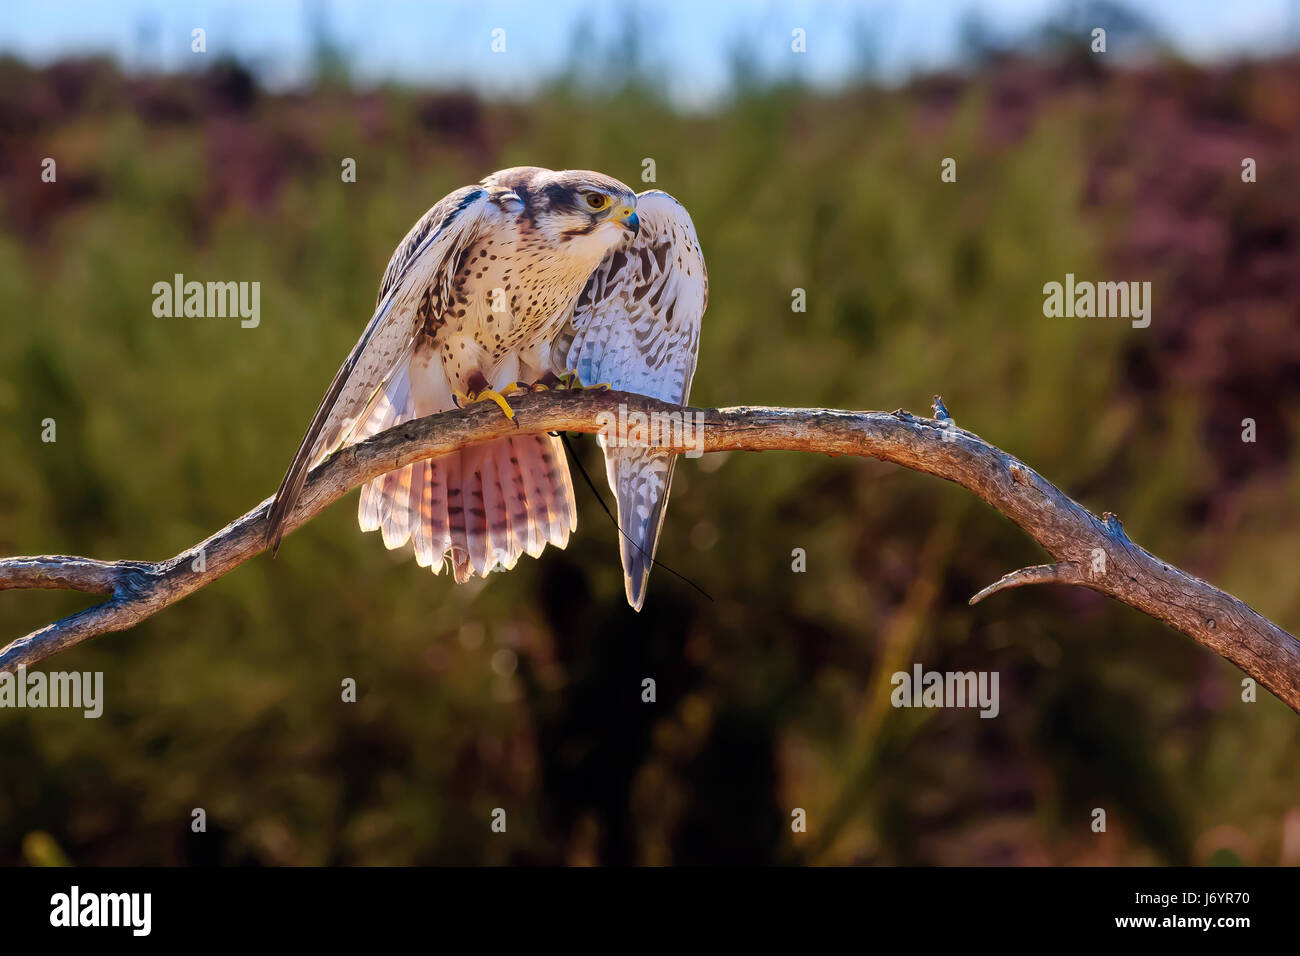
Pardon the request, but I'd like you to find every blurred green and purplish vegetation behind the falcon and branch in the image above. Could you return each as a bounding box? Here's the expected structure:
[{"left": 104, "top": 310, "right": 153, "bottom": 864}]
[{"left": 0, "top": 54, "right": 1300, "bottom": 864}]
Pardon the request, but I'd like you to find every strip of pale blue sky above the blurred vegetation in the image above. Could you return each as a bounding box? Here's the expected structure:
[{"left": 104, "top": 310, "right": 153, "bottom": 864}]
[{"left": 0, "top": 0, "right": 1300, "bottom": 101}]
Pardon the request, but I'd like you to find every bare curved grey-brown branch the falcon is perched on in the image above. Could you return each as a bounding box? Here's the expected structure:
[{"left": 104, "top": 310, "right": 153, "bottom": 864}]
[{"left": 0, "top": 390, "right": 1300, "bottom": 713}]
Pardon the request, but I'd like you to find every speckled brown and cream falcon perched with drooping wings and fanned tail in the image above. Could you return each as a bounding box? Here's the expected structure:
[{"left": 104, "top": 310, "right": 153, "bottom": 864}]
[{"left": 267, "top": 166, "right": 707, "bottom": 610}]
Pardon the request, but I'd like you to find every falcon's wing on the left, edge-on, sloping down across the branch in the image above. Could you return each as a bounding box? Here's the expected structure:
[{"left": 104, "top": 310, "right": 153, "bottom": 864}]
[{"left": 267, "top": 186, "right": 501, "bottom": 553}]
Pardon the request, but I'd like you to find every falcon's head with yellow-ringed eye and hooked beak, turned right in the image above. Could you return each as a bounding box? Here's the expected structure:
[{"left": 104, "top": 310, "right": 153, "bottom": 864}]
[{"left": 484, "top": 166, "right": 641, "bottom": 263}]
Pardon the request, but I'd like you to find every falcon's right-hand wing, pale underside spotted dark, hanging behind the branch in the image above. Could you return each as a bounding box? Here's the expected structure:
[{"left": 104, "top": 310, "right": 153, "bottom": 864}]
[{"left": 551, "top": 190, "right": 709, "bottom": 610}]
